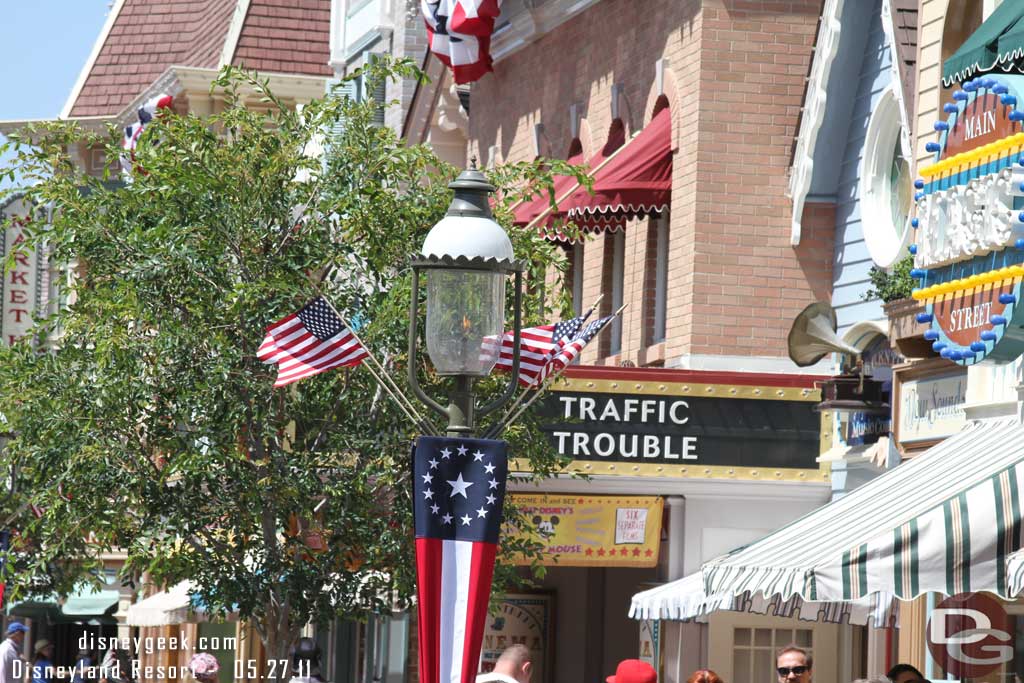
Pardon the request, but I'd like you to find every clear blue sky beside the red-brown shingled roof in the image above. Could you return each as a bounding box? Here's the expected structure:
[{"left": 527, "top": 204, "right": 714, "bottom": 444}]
[{"left": 0, "top": 0, "right": 112, "bottom": 186}]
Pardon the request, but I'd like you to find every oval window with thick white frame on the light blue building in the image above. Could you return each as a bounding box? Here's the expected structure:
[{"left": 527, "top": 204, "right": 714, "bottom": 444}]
[{"left": 860, "top": 85, "right": 913, "bottom": 268}]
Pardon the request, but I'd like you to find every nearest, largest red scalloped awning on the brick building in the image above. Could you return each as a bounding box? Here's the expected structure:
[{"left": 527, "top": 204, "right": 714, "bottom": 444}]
[{"left": 560, "top": 108, "right": 672, "bottom": 223}]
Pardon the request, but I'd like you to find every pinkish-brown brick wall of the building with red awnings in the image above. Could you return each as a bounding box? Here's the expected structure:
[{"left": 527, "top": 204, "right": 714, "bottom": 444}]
[{"left": 470, "top": 0, "right": 835, "bottom": 366}]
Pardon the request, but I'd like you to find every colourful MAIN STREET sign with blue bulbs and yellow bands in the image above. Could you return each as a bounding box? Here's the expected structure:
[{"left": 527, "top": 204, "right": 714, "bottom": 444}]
[{"left": 910, "top": 76, "right": 1024, "bottom": 366}]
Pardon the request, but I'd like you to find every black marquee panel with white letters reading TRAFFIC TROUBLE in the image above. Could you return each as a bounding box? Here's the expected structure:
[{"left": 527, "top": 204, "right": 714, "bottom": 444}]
[{"left": 537, "top": 391, "right": 821, "bottom": 469}]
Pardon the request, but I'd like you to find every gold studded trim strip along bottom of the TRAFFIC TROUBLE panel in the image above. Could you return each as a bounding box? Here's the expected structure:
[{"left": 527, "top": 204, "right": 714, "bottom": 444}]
[{"left": 509, "top": 458, "right": 831, "bottom": 482}]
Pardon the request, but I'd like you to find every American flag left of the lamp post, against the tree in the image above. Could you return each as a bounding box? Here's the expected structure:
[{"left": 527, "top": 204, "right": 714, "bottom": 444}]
[{"left": 256, "top": 296, "right": 367, "bottom": 387}]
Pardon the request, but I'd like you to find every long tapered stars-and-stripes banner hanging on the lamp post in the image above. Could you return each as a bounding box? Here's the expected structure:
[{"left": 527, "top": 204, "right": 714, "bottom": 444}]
[{"left": 413, "top": 436, "right": 508, "bottom": 683}]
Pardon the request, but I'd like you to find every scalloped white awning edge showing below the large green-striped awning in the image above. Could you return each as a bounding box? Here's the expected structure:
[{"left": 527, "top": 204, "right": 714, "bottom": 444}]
[{"left": 630, "top": 571, "right": 899, "bottom": 628}]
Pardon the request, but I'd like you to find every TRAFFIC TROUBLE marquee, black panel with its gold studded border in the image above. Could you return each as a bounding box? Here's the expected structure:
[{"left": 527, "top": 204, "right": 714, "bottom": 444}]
[{"left": 535, "top": 371, "right": 827, "bottom": 479}]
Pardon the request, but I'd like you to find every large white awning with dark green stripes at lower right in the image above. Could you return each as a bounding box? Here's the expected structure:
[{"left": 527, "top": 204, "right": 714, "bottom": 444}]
[{"left": 701, "top": 419, "right": 1024, "bottom": 601}]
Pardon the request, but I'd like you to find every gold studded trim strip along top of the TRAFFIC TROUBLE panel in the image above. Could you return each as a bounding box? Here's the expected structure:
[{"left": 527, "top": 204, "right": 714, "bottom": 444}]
[{"left": 551, "top": 377, "right": 821, "bottom": 403}]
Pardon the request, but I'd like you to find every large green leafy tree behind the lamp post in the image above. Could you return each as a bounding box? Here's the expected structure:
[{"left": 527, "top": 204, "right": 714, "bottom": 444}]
[{"left": 0, "top": 62, "right": 578, "bottom": 679}]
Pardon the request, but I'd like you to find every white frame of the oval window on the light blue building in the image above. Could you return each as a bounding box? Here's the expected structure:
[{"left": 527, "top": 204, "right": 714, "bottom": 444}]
[{"left": 860, "top": 84, "right": 912, "bottom": 268}]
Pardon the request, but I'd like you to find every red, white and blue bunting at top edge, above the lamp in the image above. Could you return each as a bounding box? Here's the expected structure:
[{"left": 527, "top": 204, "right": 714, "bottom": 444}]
[{"left": 421, "top": 0, "right": 502, "bottom": 84}]
